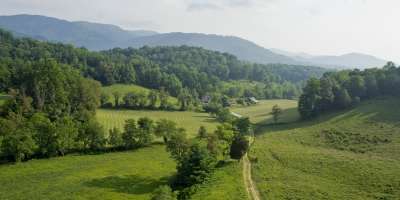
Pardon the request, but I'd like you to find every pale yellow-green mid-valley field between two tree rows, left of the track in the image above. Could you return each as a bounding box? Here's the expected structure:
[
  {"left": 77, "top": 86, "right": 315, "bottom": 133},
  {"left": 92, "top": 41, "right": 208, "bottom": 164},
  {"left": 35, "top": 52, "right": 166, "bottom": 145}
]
[{"left": 96, "top": 109, "right": 218, "bottom": 136}]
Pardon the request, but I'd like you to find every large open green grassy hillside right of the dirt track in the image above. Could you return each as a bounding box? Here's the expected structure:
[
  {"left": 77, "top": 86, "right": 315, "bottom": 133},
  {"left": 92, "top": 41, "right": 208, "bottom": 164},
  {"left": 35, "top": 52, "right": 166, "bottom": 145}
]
[{"left": 251, "top": 98, "right": 400, "bottom": 200}]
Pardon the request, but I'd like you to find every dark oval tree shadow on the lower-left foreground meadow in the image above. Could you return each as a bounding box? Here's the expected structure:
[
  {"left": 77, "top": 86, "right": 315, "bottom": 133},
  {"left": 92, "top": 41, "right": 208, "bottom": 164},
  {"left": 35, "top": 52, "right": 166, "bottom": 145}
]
[{"left": 84, "top": 175, "right": 170, "bottom": 194}]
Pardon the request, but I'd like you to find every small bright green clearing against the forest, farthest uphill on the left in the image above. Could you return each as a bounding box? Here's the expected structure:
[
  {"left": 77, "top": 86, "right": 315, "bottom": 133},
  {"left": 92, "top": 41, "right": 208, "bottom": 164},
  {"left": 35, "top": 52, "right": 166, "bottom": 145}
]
[{"left": 101, "top": 84, "right": 178, "bottom": 104}]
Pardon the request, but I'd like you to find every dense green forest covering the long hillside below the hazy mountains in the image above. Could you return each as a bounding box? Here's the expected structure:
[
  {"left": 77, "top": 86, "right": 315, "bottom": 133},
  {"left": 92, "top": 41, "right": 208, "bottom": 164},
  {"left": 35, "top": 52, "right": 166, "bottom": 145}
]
[{"left": 0, "top": 28, "right": 326, "bottom": 98}]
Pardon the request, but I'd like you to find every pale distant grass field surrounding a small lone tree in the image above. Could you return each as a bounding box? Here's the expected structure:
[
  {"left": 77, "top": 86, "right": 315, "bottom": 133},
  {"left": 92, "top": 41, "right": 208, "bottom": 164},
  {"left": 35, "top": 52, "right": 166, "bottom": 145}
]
[{"left": 231, "top": 99, "right": 299, "bottom": 124}]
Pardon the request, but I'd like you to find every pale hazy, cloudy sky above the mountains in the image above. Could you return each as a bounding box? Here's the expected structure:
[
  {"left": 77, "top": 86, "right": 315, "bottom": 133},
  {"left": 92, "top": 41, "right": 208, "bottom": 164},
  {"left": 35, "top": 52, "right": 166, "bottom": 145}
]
[{"left": 0, "top": 0, "right": 400, "bottom": 61}]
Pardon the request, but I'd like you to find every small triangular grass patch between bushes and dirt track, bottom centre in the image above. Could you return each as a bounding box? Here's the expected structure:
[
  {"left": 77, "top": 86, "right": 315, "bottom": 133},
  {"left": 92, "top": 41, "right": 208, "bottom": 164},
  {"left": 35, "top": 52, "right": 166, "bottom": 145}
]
[{"left": 192, "top": 161, "right": 248, "bottom": 200}]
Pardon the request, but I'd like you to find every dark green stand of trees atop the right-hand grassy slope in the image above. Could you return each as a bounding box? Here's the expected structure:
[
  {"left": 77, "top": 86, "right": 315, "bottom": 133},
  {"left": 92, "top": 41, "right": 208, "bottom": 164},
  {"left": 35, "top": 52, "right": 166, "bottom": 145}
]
[{"left": 299, "top": 62, "right": 400, "bottom": 119}]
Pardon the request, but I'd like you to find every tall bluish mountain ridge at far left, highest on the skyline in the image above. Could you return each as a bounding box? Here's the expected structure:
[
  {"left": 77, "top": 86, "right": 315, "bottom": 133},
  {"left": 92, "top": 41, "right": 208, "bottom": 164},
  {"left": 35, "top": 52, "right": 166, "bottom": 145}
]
[{"left": 0, "top": 15, "right": 157, "bottom": 50}]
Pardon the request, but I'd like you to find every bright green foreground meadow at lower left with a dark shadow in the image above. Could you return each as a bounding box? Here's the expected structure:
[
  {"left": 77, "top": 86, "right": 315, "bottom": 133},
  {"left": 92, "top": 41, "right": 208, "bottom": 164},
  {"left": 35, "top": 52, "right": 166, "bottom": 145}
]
[{"left": 0, "top": 145, "right": 175, "bottom": 200}]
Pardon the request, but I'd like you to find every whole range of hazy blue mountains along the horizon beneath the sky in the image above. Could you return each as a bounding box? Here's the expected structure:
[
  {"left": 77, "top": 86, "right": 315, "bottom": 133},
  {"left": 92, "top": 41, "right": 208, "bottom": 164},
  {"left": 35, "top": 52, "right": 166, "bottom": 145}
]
[{"left": 0, "top": 15, "right": 386, "bottom": 68}]
